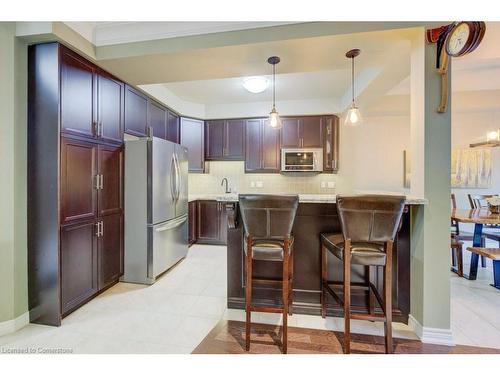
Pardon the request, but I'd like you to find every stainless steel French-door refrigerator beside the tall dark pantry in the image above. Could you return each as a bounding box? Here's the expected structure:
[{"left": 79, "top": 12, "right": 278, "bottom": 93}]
[{"left": 122, "top": 137, "right": 188, "bottom": 284}]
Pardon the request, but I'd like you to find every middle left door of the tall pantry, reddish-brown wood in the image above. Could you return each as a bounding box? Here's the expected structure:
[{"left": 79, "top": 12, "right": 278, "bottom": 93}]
[{"left": 60, "top": 138, "right": 98, "bottom": 224}]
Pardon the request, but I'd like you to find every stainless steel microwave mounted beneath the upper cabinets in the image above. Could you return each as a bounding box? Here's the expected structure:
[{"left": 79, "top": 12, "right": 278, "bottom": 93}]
[{"left": 281, "top": 148, "right": 323, "bottom": 172}]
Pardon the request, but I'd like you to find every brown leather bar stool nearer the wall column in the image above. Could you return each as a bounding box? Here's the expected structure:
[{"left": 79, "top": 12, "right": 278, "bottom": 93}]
[{"left": 321, "top": 195, "right": 405, "bottom": 353}]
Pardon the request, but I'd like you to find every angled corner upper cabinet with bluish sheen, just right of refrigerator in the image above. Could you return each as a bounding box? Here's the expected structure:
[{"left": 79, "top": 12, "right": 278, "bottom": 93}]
[{"left": 181, "top": 117, "right": 205, "bottom": 172}]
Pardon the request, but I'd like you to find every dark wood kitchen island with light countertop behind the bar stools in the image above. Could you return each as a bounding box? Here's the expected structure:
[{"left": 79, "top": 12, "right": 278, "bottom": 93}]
[{"left": 212, "top": 194, "right": 426, "bottom": 323}]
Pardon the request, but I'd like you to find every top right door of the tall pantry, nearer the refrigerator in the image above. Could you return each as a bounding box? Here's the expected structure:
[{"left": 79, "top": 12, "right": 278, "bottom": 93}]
[{"left": 97, "top": 71, "right": 124, "bottom": 143}]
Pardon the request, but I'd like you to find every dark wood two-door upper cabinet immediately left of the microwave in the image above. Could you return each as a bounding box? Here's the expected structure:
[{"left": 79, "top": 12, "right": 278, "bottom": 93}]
[{"left": 245, "top": 119, "right": 280, "bottom": 173}]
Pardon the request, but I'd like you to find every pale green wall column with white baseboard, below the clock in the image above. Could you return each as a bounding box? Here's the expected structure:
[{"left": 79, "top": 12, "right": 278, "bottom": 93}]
[{"left": 409, "top": 28, "right": 453, "bottom": 345}]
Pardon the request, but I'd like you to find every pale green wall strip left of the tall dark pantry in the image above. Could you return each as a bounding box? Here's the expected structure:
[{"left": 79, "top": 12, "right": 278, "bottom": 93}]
[{"left": 0, "top": 22, "right": 28, "bottom": 322}]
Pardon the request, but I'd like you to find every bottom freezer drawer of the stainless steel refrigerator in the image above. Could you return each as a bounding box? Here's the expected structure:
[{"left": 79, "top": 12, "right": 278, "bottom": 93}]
[{"left": 148, "top": 215, "right": 188, "bottom": 280}]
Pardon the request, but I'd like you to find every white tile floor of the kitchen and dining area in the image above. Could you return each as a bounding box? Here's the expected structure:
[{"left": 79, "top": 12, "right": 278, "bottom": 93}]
[{"left": 0, "top": 245, "right": 500, "bottom": 354}]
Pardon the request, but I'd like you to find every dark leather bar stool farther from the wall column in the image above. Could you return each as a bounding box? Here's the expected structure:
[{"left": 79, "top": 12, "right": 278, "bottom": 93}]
[{"left": 239, "top": 194, "right": 299, "bottom": 353}]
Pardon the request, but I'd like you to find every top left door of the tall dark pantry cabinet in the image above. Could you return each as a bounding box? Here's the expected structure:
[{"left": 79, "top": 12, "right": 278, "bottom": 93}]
[{"left": 60, "top": 48, "right": 97, "bottom": 137}]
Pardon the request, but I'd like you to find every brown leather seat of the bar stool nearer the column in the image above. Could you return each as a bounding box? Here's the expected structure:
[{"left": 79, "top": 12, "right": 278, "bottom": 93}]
[{"left": 321, "top": 233, "right": 386, "bottom": 266}]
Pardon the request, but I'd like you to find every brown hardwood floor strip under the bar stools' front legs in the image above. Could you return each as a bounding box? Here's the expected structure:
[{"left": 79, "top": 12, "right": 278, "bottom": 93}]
[{"left": 193, "top": 320, "right": 500, "bottom": 354}]
